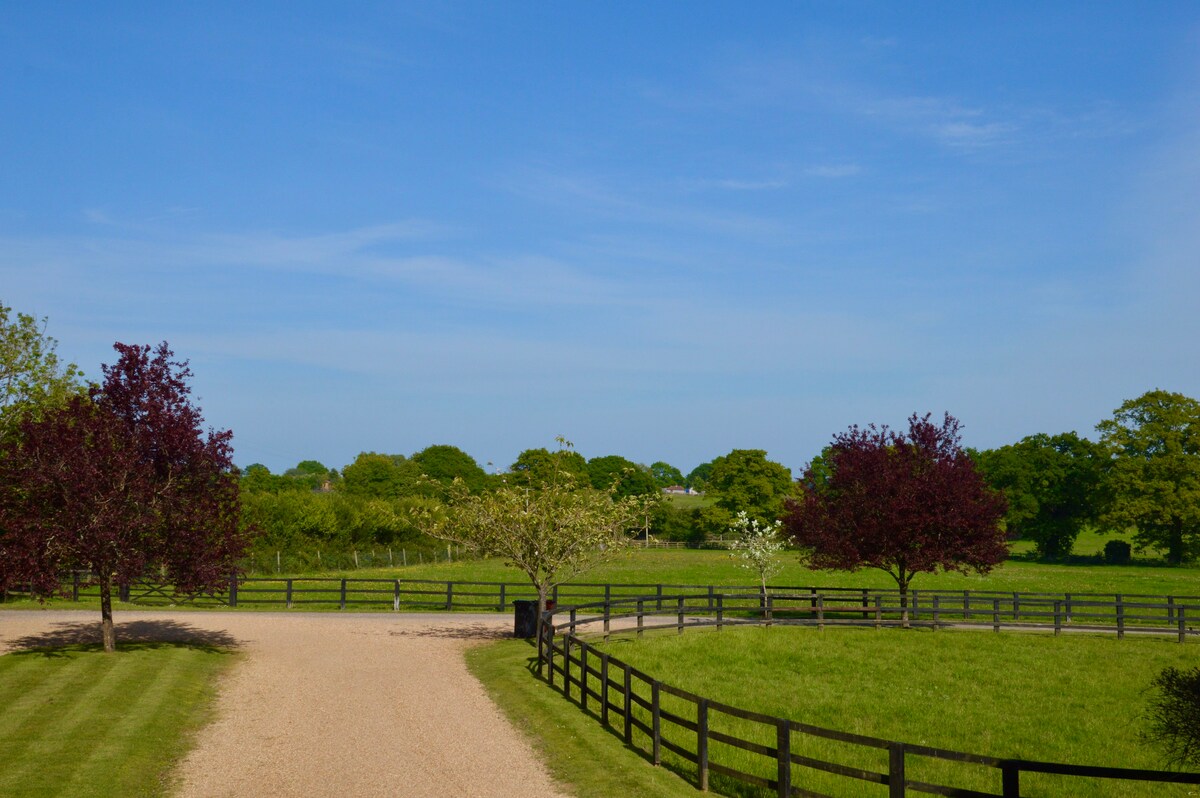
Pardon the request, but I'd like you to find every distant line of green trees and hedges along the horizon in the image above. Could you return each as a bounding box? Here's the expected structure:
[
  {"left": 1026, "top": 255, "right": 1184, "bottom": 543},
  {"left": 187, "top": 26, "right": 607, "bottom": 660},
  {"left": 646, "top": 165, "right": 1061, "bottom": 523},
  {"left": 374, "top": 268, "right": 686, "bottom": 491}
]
[{"left": 241, "top": 390, "right": 1200, "bottom": 563}]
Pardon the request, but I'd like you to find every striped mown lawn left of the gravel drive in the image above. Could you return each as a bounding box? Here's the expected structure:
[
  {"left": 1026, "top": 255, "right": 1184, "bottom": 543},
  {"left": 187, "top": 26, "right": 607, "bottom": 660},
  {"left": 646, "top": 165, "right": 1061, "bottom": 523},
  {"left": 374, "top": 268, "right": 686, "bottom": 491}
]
[{"left": 0, "top": 643, "right": 234, "bottom": 798}]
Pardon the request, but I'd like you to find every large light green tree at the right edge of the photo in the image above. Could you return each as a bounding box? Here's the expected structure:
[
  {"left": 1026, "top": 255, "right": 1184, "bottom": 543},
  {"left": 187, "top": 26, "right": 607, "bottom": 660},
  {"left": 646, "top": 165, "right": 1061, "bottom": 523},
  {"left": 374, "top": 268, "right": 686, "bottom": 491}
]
[{"left": 1096, "top": 390, "right": 1200, "bottom": 564}]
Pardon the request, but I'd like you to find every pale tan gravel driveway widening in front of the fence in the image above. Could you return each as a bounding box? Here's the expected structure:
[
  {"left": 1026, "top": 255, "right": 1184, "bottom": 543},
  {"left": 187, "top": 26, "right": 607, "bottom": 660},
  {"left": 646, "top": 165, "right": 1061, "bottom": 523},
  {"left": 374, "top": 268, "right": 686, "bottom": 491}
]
[{"left": 0, "top": 611, "right": 568, "bottom": 798}]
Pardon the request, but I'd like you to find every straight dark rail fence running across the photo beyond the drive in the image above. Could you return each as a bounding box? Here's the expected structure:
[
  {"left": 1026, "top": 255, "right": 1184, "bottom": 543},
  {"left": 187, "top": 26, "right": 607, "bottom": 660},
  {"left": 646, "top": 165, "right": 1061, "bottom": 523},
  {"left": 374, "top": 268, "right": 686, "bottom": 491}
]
[{"left": 7, "top": 571, "right": 1200, "bottom": 642}]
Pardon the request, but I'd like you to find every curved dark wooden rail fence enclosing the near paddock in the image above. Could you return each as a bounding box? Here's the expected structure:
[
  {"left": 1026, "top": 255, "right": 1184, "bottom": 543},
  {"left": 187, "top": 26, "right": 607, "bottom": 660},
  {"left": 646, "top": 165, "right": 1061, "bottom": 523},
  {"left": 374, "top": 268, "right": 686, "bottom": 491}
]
[{"left": 536, "top": 592, "right": 1200, "bottom": 798}]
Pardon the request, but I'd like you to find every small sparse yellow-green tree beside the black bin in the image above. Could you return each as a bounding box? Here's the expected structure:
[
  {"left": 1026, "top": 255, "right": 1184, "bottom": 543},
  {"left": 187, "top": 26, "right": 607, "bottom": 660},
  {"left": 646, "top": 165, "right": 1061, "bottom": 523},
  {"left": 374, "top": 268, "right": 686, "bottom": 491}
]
[{"left": 414, "top": 438, "right": 646, "bottom": 618}]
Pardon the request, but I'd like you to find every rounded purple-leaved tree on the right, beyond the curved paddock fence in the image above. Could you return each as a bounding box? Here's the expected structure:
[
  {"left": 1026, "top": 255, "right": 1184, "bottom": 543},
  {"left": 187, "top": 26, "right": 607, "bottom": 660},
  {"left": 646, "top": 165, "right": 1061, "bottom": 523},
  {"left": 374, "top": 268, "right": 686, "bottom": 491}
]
[{"left": 784, "top": 414, "right": 1008, "bottom": 625}]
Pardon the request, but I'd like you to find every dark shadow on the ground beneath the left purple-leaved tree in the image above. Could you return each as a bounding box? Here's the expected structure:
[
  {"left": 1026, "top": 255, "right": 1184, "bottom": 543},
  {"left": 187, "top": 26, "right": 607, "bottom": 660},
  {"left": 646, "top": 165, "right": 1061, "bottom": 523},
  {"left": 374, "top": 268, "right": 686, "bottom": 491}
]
[{"left": 8, "top": 619, "right": 240, "bottom": 656}]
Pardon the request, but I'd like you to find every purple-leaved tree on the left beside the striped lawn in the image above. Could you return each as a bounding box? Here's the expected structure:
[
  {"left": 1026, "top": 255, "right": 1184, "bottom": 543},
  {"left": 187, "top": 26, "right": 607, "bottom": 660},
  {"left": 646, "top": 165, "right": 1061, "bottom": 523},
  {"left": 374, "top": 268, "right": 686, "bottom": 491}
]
[{"left": 0, "top": 343, "right": 245, "bottom": 652}]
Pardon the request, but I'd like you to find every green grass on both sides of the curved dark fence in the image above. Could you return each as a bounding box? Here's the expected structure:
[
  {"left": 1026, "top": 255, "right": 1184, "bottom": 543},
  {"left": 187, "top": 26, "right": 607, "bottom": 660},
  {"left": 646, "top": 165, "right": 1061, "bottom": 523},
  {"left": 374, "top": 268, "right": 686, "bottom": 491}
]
[{"left": 482, "top": 626, "right": 1196, "bottom": 798}]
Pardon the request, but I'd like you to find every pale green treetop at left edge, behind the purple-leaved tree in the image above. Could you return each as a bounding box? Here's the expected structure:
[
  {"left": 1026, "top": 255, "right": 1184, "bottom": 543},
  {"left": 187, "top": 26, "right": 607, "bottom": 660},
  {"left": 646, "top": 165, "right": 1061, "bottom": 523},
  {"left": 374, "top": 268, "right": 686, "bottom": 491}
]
[{"left": 0, "top": 302, "right": 82, "bottom": 440}]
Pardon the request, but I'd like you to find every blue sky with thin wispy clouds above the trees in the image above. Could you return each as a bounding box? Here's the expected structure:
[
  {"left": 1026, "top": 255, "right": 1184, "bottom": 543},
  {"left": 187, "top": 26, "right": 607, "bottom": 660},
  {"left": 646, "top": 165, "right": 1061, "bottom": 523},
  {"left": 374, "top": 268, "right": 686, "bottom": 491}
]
[{"left": 0, "top": 2, "right": 1200, "bottom": 473}]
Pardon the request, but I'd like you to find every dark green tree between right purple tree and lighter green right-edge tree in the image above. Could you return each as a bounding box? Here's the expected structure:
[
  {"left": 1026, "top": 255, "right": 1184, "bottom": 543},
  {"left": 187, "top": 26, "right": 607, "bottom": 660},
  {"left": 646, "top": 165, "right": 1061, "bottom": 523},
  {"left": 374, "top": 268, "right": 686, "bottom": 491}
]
[{"left": 974, "top": 432, "right": 1104, "bottom": 559}]
